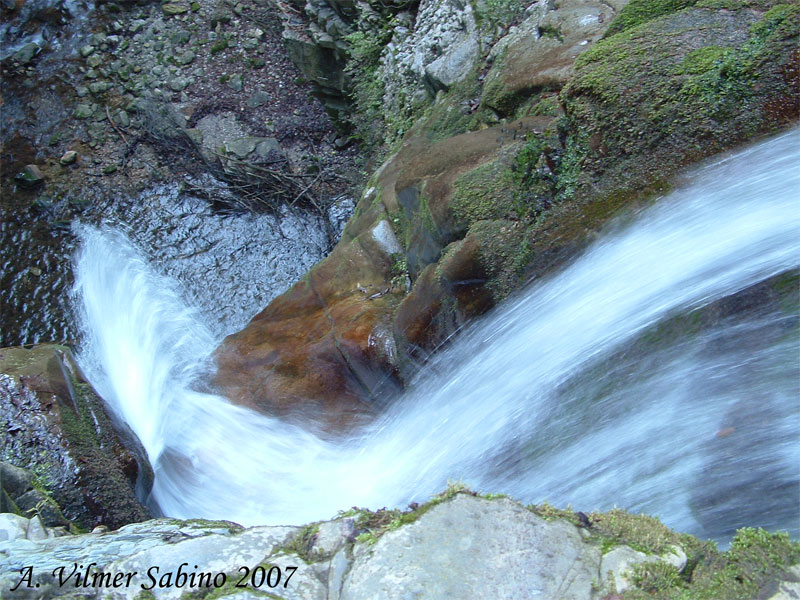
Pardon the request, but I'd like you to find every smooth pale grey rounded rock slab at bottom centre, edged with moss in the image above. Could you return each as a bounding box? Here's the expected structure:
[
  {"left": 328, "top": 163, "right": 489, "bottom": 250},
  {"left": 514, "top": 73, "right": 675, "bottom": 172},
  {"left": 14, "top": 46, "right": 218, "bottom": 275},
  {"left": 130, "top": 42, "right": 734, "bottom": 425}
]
[{"left": 340, "top": 494, "right": 600, "bottom": 600}]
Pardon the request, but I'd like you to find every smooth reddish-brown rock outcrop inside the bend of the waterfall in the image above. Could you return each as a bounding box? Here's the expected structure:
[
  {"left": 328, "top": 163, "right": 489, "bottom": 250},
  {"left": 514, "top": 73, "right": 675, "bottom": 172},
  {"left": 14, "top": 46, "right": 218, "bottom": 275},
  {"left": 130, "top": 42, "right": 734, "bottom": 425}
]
[{"left": 209, "top": 117, "right": 552, "bottom": 428}]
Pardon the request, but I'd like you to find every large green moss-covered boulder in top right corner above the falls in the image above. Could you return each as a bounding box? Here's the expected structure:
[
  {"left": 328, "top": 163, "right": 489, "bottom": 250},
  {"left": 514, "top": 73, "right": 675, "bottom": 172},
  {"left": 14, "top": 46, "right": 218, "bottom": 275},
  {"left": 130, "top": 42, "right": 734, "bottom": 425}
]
[{"left": 559, "top": 0, "right": 800, "bottom": 199}]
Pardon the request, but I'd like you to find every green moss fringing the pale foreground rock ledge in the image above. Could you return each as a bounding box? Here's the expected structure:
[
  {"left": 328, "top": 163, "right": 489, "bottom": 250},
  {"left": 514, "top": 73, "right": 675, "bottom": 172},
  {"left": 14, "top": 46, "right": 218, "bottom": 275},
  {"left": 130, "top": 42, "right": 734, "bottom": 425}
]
[{"left": 346, "top": 483, "right": 800, "bottom": 600}]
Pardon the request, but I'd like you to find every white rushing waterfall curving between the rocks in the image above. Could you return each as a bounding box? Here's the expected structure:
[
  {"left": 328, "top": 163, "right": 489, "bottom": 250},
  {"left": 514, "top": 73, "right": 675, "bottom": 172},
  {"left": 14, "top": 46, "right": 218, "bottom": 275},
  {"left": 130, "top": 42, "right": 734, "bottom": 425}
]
[{"left": 76, "top": 132, "right": 800, "bottom": 538}]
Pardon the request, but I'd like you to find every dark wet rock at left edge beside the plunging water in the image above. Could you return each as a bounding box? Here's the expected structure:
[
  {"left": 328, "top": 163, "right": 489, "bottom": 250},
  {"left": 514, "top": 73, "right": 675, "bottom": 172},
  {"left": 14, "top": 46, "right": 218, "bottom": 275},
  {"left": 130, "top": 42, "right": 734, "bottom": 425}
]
[{"left": 0, "top": 344, "right": 153, "bottom": 528}]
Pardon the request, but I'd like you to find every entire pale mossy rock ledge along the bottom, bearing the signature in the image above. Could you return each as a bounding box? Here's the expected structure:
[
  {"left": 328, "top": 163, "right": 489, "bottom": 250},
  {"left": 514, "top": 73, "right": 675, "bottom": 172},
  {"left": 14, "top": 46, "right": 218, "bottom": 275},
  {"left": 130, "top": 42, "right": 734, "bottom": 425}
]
[{"left": 0, "top": 488, "right": 800, "bottom": 600}]
